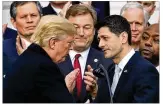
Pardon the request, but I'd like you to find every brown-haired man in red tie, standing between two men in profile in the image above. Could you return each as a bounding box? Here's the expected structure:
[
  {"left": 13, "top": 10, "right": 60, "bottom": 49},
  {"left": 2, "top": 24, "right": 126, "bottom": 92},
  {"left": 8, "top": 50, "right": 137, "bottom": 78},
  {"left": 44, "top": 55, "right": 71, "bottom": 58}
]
[{"left": 58, "top": 4, "right": 111, "bottom": 103}]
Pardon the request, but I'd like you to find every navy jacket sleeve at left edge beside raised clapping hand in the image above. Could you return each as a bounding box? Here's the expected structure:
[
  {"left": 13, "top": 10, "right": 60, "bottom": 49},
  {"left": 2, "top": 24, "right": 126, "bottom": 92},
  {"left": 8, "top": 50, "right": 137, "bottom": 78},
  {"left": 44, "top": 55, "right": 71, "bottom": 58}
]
[{"left": 3, "top": 38, "right": 19, "bottom": 64}]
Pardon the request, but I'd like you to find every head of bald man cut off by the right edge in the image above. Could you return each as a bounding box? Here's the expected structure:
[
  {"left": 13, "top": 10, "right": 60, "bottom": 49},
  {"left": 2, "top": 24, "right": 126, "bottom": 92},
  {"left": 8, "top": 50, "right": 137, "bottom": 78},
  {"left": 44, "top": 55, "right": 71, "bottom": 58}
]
[{"left": 140, "top": 23, "right": 160, "bottom": 71}]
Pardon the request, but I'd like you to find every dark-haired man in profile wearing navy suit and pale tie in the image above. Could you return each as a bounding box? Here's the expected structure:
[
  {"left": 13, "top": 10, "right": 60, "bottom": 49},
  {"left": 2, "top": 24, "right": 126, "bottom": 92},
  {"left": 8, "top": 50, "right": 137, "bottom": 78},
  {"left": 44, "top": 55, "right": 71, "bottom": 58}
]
[{"left": 94, "top": 15, "right": 159, "bottom": 103}]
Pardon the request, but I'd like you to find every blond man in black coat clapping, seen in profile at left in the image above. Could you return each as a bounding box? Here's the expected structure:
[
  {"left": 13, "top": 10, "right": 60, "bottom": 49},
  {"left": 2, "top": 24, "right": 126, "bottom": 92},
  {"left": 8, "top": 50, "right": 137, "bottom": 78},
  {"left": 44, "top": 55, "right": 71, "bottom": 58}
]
[{"left": 3, "top": 15, "right": 78, "bottom": 103}]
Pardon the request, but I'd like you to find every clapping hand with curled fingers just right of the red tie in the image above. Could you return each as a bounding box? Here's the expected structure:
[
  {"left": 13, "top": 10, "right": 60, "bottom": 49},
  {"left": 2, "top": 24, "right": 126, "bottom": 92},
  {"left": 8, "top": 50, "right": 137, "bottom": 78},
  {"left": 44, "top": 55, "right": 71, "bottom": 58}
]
[{"left": 84, "top": 65, "right": 98, "bottom": 98}]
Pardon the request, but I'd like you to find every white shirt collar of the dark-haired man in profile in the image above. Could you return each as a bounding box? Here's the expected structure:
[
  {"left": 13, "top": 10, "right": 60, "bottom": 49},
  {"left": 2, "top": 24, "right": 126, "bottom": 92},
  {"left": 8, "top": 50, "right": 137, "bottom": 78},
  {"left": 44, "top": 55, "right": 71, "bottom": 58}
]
[{"left": 118, "top": 49, "right": 135, "bottom": 70}]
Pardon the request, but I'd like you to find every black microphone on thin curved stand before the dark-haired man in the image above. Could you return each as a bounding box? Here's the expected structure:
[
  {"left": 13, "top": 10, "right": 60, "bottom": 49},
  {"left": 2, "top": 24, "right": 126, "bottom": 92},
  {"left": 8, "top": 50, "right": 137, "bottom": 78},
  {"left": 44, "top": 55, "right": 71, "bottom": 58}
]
[{"left": 93, "top": 59, "right": 113, "bottom": 103}]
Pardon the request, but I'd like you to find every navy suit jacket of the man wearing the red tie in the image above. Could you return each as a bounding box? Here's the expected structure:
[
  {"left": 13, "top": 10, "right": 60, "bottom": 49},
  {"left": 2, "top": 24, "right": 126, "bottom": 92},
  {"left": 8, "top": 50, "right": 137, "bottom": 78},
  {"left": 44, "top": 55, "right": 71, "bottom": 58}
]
[{"left": 58, "top": 48, "right": 112, "bottom": 103}]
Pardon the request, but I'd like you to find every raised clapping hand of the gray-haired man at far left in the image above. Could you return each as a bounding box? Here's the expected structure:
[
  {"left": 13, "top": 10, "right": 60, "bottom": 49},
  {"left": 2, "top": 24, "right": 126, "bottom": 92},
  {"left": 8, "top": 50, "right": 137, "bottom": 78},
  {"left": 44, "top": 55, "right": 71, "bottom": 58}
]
[{"left": 16, "top": 35, "right": 26, "bottom": 55}]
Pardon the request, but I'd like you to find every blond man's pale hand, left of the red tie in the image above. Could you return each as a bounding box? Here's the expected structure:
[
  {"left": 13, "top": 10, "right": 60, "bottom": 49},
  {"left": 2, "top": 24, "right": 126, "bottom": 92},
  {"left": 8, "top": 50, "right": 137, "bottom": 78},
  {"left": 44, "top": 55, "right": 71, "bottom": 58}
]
[{"left": 65, "top": 69, "right": 79, "bottom": 93}]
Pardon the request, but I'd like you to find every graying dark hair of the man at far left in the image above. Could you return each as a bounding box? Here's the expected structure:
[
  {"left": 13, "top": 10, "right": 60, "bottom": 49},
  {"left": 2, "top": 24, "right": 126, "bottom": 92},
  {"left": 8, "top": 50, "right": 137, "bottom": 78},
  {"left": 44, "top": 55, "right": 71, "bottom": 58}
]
[{"left": 10, "top": 1, "right": 42, "bottom": 20}]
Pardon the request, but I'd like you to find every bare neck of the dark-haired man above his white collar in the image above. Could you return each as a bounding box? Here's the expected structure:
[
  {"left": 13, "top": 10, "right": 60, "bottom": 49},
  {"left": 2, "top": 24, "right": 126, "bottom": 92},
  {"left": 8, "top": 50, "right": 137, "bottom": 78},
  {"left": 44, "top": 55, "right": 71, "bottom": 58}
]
[{"left": 113, "top": 45, "right": 132, "bottom": 64}]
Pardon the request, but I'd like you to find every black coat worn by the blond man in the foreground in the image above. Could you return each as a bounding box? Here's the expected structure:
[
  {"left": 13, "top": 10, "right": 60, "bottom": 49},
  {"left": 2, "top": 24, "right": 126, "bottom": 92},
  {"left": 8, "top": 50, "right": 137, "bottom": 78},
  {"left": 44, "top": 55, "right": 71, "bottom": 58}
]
[{"left": 3, "top": 44, "right": 74, "bottom": 103}]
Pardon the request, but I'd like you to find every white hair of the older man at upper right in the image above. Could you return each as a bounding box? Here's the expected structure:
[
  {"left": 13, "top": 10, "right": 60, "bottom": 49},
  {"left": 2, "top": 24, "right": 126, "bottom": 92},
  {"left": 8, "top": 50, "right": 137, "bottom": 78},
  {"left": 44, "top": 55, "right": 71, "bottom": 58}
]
[{"left": 120, "top": 2, "right": 150, "bottom": 25}]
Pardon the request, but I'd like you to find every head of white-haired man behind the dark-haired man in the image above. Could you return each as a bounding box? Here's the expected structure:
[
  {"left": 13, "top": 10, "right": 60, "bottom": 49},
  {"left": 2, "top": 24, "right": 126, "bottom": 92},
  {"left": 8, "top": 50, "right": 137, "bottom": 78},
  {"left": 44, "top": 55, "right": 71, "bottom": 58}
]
[{"left": 120, "top": 2, "right": 149, "bottom": 51}]
